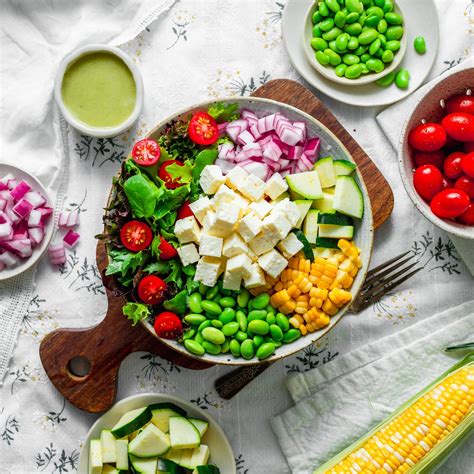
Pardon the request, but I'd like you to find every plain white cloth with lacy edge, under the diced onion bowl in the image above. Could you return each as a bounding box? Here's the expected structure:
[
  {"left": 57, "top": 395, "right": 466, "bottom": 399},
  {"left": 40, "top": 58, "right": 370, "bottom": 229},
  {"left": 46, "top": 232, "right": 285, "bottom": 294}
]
[{"left": 0, "top": 0, "right": 175, "bottom": 385}]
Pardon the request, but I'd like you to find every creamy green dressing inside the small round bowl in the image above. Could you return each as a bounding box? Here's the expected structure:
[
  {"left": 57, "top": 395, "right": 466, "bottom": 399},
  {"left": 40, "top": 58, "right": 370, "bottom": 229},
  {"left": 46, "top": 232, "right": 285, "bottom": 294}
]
[{"left": 61, "top": 51, "right": 137, "bottom": 128}]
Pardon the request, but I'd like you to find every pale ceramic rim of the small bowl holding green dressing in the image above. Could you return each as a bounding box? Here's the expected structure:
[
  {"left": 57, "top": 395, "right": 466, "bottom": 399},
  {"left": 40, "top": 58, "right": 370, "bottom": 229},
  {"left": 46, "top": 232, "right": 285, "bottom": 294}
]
[{"left": 54, "top": 44, "right": 143, "bottom": 138}]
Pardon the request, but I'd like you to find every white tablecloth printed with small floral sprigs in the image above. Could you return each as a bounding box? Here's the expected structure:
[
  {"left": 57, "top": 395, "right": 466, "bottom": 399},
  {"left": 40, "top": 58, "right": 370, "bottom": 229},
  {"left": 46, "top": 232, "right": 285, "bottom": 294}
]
[{"left": 0, "top": 0, "right": 474, "bottom": 474}]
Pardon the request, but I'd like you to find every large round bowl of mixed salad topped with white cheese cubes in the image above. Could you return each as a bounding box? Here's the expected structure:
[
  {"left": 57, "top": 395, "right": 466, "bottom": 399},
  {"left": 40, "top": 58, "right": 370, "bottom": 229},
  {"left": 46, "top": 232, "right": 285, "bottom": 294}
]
[{"left": 102, "top": 98, "right": 373, "bottom": 365}]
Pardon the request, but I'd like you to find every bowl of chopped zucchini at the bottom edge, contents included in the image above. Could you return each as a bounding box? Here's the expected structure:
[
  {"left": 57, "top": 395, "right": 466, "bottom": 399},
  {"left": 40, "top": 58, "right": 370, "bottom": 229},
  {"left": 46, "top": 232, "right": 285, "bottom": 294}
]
[{"left": 78, "top": 393, "right": 236, "bottom": 474}]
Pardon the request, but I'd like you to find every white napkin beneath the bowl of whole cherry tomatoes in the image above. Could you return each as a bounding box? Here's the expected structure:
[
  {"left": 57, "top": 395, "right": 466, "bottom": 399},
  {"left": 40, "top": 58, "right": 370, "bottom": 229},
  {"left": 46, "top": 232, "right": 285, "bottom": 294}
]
[{"left": 377, "top": 57, "right": 474, "bottom": 275}]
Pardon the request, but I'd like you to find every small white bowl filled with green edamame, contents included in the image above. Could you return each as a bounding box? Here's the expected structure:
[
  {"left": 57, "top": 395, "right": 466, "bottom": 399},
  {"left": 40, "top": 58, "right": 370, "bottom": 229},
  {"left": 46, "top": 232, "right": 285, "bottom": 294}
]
[{"left": 303, "top": 0, "right": 407, "bottom": 85}]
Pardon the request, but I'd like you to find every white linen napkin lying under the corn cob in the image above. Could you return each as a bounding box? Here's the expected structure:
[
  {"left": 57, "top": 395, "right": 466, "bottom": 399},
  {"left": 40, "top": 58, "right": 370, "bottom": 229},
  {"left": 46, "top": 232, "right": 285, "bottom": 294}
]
[{"left": 271, "top": 300, "right": 474, "bottom": 474}]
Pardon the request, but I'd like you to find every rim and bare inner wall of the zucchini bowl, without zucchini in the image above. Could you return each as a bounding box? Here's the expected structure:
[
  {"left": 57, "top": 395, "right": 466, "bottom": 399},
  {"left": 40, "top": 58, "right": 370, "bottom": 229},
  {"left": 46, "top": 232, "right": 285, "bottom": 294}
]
[{"left": 78, "top": 393, "right": 237, "bottom": 474}]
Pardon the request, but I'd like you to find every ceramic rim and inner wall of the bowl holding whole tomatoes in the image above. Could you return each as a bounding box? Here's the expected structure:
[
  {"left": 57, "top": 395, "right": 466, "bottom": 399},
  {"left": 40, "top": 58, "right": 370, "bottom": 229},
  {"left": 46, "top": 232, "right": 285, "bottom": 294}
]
[{"left": 398, "top": 68, "right": 474, "bottom": 239}]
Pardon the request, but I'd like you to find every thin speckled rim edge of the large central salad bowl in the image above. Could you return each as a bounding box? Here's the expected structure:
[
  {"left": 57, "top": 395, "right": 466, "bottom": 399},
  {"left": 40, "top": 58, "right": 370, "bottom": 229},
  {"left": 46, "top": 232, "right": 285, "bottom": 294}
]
[{"left": 107, "top": 97, "right": 374, "bottom": 366}]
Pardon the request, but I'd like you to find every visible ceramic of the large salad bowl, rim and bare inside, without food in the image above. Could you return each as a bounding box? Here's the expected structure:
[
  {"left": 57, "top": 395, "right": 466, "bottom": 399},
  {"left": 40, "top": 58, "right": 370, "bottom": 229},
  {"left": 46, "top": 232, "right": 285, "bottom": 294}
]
[{"left": 104, "top": 98, "right": 374, "bottom": 365}]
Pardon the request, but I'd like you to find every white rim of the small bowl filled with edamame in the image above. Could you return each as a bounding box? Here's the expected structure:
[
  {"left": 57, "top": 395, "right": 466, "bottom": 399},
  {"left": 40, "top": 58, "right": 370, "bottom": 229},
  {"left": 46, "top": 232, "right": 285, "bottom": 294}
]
[{"left": 303, "top": 0, "right": 408, "bottom": 86}]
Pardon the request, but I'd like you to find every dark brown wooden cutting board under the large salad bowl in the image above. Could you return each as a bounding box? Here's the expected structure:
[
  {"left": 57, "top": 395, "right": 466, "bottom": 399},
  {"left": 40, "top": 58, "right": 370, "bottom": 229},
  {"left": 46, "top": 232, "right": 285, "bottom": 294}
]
[{"left": 40, "top": 79, "right": 393, "bottom": 413}]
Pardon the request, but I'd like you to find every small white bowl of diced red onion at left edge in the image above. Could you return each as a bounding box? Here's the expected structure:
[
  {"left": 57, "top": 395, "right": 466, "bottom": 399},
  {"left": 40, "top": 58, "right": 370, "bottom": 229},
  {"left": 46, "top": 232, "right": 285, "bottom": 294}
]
[{"left": 0, "top": 164, "right": 54, "bottom": 281}]
